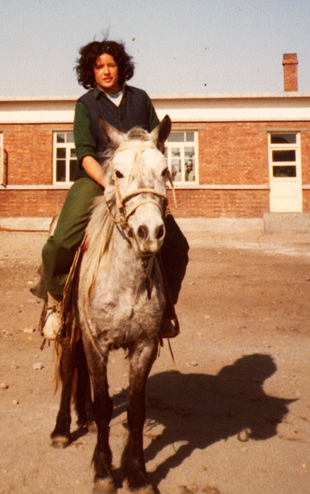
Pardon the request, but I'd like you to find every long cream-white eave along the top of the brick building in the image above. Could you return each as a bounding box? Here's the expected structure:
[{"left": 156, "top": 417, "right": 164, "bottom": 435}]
[{"left": 0, "top": 92, "right": 310, "bottom": 125}]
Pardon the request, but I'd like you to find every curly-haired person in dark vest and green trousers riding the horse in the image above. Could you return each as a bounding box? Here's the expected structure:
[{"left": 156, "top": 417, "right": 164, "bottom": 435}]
[{"left": 42, "top": 40, "right": 188, "bottom": 339}]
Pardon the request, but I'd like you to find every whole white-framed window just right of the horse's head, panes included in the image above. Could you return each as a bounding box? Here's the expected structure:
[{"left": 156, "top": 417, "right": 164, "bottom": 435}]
[{"left": 165, "top": 130, "right": 198, "bottom": 184}]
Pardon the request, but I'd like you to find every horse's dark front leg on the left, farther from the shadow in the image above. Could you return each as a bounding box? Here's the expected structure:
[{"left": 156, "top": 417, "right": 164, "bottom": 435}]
[{"left": 83, "top": 336, "right": 117, "bottom": 494}]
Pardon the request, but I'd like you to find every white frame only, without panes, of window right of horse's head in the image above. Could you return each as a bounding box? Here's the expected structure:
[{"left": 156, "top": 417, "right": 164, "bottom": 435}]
[{"left": 165, "top": 128, "right": 199, "bottom": 188}]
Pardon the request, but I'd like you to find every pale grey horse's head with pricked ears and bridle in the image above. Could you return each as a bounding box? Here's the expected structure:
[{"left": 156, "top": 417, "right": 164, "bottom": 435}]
[{"left": 100, "top": 116, "right": 171, "bottom": 256}]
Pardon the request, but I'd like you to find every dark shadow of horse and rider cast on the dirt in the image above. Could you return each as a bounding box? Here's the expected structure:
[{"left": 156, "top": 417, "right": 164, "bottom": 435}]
[{"left": 114, "top": 354, "right": 295, "bottom": 485}]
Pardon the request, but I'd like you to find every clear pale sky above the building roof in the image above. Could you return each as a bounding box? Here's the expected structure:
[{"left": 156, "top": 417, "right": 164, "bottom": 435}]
[{"left": 0, "top": 0, "right": 310, "bottom": 97}]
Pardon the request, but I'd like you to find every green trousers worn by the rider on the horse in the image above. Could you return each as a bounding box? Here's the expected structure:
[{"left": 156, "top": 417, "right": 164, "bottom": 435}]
[{"left": 42, "top": 178, "right": 189, "bottom": 305}]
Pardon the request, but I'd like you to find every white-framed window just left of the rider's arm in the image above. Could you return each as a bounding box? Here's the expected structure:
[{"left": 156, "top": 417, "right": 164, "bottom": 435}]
[{"left": 54, "top": 132, "right": 77, "bottom": 184}]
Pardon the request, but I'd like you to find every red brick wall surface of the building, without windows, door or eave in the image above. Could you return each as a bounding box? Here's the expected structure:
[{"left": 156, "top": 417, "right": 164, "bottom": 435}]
[{"left": 0, "top": 122, "right": 310, "bottom": 218}]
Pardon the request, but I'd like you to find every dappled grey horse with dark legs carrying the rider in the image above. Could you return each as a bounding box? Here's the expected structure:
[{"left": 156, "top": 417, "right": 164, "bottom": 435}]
[{"left": 51, "top": 116, "right": 171, "bottom": 494}]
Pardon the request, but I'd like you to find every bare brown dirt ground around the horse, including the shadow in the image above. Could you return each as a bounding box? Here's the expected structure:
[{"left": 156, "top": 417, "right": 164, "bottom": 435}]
[{"left": 0, "top": 231, "right": 310, "bottom": 494}]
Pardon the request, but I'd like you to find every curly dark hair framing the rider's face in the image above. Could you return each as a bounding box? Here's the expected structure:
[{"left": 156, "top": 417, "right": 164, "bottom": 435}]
[{"left": 75, "top": 40, "right": 135, "bottom": 89}]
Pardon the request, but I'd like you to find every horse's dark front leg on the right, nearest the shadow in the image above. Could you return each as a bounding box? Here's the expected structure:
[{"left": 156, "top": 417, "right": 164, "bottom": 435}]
[{"left": 122, "top": 342, "right": 158, "bottom": 494}]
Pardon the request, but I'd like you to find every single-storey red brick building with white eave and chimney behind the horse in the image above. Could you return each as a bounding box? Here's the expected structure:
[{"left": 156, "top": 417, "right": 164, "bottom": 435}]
[{"left": 0, "top": 54, "right": 310, "bottom": 231}]
